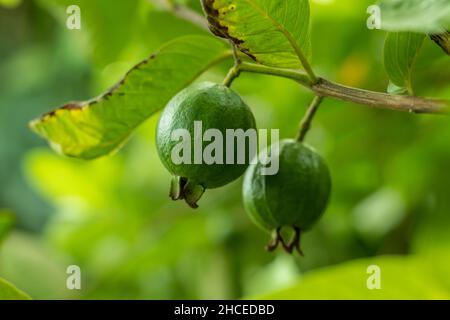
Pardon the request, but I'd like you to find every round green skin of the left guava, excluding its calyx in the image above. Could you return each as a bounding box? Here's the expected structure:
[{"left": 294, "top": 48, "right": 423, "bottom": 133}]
[{"left": 156, "top": 82, "right": 256, "bottom": 189}]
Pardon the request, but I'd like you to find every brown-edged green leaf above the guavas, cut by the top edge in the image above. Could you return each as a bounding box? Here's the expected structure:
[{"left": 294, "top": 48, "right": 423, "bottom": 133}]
[{"left": 202, "top": 0, "right": 310, "bottom": 68}]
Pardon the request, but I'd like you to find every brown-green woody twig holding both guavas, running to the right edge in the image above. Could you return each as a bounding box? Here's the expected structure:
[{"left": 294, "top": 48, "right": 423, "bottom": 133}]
[{"left": 234, "top": 62, "right": 450, "bottom": 114}]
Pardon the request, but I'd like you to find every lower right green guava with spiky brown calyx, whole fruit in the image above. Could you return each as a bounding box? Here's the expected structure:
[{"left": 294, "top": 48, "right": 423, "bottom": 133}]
[{"left": 243, "top": 140, "right": 331, "bottom": 254}]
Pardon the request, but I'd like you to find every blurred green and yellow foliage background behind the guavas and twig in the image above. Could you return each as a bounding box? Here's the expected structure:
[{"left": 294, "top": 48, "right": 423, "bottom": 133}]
[{"left": 0, "top": 0, "right": 450, "bottom": 299}]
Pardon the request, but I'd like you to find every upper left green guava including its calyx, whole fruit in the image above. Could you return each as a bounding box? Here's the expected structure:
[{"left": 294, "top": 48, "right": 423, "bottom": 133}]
[{"left": 156, "top": 82, "right": 256, "bottom": 208}]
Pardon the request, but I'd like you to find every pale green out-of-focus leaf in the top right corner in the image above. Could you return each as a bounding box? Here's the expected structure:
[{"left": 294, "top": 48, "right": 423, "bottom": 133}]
[{"left": 379, "top": 0, "right": 450, "bottom": 33}]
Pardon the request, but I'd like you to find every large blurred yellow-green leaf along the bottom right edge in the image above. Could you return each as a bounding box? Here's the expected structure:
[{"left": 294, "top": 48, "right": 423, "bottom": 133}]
[{"left": 253, "top": 256, "right": 450, "bottom": 300}]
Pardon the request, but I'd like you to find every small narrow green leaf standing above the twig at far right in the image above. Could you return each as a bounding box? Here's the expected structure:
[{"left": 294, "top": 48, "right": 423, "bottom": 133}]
[{"left": 384, "top": 32, "right": 425, "bottom": 94}]
